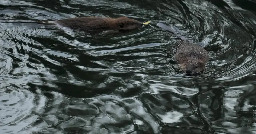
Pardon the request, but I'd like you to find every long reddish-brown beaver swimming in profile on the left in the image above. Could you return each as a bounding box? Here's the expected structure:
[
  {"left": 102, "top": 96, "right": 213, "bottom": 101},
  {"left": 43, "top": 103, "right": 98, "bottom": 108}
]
[{"left": 56, "top": 17, "right": 143, "bottom": 33}]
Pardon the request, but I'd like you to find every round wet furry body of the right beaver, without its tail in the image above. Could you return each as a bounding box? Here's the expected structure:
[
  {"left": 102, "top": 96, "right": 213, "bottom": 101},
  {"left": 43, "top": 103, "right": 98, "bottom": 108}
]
[{"left": 174, "top": 41, "right": 209, "bottom": 75}]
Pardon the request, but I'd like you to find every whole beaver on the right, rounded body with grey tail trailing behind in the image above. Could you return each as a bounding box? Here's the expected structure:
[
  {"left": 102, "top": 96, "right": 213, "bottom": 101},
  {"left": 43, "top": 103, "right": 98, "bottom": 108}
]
[{"left": 157, "top": 23, "right": 209, "bottom": 75}]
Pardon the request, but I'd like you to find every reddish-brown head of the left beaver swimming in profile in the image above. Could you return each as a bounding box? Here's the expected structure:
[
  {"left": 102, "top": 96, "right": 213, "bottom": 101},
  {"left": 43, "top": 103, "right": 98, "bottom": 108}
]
[{"left": 110, "top": 17, "right": 143, "bottom": 32}]
